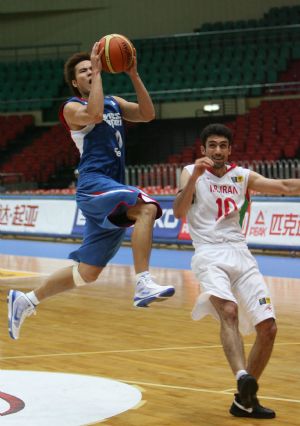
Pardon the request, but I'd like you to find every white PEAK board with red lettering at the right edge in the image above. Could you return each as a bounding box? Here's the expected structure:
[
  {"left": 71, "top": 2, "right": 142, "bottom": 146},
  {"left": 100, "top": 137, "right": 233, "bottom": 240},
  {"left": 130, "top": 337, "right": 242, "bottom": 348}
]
[{"left": 243, "top": 199, "right": 300, "bottom": 248}]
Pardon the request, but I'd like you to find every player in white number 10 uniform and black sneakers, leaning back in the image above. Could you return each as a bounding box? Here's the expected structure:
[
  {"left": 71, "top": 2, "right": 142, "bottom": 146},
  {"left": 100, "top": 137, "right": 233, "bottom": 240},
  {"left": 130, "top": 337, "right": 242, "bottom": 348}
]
[{"left": 174, "top": 124, "right": 300, "bottom": 419}]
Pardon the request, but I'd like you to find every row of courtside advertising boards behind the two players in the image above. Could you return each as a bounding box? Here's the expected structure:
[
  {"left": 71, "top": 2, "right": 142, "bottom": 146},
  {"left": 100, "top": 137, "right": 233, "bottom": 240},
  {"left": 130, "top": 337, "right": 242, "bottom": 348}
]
[{"left": 0, "top": 196, "right": 300, "bottom": 250}]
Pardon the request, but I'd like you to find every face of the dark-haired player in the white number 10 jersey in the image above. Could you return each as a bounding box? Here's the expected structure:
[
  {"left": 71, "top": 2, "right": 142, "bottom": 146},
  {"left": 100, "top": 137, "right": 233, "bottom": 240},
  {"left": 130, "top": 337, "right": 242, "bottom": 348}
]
[{"left": 201, "top": 135, "right": 231, "bottom": 169}]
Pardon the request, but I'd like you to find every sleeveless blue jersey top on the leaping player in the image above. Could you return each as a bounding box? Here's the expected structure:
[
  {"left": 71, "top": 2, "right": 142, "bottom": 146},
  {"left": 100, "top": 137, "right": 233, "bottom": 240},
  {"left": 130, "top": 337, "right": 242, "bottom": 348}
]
[{"left": 60, "top": 96, "right": 125, "bottom": 186}]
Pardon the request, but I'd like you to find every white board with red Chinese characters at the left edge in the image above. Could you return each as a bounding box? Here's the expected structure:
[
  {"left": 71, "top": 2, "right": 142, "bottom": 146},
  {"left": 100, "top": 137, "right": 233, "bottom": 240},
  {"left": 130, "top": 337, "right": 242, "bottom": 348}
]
[{"left": 0, "top": 197, "right": 76, "bottom": 236}]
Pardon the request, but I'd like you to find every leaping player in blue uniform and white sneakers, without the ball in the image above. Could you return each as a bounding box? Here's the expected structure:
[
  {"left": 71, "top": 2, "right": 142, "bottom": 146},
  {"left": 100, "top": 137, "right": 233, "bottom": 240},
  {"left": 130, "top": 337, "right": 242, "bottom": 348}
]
[{"left": 8, "top": 43, "right": 175, "bottom": 339}]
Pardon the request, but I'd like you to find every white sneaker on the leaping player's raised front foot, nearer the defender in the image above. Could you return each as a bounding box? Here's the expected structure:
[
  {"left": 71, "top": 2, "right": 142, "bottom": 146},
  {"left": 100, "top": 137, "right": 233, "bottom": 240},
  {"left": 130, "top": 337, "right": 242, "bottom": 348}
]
[{"left": 133, "top": 274, "right": 175, "bottom": 308}]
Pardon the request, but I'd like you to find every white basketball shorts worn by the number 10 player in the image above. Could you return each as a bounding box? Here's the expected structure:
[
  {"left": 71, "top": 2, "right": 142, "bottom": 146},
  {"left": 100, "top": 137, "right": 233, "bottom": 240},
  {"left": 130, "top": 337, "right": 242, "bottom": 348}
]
[{"left": 192, "top": 243, "right": 275, "bottom": 334}]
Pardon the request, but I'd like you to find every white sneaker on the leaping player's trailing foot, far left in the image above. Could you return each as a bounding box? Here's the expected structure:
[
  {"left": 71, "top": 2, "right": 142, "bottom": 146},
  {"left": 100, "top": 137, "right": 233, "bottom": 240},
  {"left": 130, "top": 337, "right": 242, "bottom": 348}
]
[{"left": 7, "top": 290, "right": 36, "bottom": 339}]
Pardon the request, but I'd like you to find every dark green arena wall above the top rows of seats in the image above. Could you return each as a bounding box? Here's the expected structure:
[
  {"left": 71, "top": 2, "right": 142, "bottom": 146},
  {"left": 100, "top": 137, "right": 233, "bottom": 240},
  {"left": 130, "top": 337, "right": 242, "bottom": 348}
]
[{"left": 0, "top": 0, "right": 299, "bottom": 49}]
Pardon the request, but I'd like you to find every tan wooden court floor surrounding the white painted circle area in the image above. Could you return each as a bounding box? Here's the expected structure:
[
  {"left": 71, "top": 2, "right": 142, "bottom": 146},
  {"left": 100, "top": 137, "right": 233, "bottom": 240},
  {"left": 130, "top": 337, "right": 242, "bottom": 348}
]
[{"left": 0, "top": 255, "right": 300, "bottom": 426}]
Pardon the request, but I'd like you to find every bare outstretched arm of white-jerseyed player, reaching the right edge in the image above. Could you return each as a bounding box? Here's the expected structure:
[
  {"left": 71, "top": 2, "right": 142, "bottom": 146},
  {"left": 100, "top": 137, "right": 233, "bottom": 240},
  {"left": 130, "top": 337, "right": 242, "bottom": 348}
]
[{"left": 248, "top": 171, "right": 300, "bottom": 195}]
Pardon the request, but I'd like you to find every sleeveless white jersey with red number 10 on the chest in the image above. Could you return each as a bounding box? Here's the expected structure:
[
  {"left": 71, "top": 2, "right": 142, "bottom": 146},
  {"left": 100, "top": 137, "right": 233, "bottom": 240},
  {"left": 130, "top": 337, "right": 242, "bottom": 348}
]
[{"left": 185, "top": 164, "right": 250, "bottom": 248}]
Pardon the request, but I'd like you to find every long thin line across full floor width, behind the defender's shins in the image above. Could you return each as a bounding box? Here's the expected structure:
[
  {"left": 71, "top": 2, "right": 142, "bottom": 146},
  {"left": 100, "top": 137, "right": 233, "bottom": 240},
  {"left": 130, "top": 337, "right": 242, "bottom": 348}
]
[{"left": 0, "top": 342, "right": 300, "bottom": 361}]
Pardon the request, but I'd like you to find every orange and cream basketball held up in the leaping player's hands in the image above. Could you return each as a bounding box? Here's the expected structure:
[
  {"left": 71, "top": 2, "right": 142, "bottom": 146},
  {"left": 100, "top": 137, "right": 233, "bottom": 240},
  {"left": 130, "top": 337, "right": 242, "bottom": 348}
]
[{"left": 100, "top": 34, "right": 134, "bottom": 73}]
